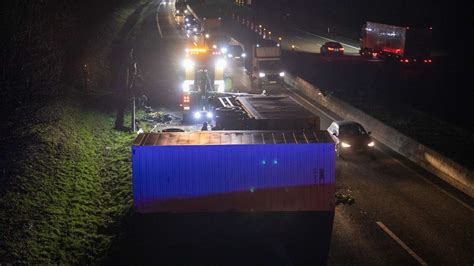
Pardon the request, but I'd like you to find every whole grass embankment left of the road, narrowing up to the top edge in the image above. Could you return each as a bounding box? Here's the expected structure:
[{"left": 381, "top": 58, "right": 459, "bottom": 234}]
[{"left": 0, "top": 0, "right": 147, "bottom": 265}]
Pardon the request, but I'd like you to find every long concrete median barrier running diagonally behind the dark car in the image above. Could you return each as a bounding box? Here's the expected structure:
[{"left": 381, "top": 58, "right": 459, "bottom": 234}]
[{"left": 285, "top": 72, "right": 474, "bottom": 198}]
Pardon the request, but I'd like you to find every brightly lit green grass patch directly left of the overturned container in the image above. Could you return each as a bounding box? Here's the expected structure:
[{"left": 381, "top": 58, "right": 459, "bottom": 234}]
[{"left": 0, "top": 107, "right": 135, "bottom": 264}]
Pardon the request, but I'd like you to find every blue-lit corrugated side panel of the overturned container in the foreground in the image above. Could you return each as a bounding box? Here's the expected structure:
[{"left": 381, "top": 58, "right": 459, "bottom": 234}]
[{"left": 132, "top": 143, "right": 335, "bottom": 212}]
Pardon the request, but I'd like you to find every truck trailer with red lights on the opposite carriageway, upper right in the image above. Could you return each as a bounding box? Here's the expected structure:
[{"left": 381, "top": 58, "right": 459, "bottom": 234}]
[{"left": 359, "top": 22, "right": 432, "bottom": 63}]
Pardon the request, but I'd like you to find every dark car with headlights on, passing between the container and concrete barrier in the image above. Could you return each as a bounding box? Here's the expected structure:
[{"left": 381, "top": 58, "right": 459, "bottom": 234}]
[{"left": 327, "top": 121, "right": 375, "bottom": 156}]
